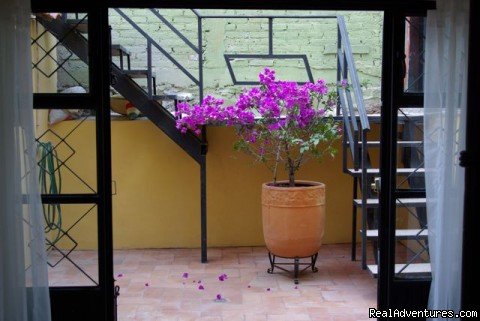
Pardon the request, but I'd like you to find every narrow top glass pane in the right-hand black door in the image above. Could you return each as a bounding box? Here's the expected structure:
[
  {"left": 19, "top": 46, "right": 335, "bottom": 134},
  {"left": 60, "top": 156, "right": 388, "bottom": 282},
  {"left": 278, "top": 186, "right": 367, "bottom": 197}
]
[{"left": 404, "top": 17, "right": 426, "bottom": 93}]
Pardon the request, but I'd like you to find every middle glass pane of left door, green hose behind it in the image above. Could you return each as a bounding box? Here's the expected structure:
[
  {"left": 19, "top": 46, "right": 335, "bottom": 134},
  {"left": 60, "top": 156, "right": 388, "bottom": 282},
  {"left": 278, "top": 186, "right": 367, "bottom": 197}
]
[{"left": 34, "top": 109, "right": 97, "bottom": 194}]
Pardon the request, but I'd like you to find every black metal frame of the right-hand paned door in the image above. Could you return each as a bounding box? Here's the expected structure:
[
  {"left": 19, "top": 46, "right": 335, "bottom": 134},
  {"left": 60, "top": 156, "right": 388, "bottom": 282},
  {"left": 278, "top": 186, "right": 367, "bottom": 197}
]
[{"left": 377, "top": 10, "right": 431, "bottom": 310}]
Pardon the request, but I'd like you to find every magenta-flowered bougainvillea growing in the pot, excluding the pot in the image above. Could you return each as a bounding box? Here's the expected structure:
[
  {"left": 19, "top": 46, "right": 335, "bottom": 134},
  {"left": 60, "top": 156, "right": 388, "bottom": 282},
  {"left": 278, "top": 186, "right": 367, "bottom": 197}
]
[{"left": 176, "top": 68, "right": 341, "bottom": 186}]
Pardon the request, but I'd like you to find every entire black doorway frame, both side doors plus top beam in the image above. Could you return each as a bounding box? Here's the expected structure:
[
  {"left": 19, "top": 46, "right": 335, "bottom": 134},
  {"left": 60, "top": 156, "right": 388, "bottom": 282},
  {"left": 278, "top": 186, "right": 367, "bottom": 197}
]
[{"left": 32, "top": 0, "right": 466, "bottom": 321}]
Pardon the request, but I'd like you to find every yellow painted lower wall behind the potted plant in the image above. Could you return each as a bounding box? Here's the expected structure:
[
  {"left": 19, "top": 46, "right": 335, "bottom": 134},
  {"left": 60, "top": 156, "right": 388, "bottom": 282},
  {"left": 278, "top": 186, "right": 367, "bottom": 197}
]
[{"left": 42, "top": 116, "right": 378, "bottom": 249}]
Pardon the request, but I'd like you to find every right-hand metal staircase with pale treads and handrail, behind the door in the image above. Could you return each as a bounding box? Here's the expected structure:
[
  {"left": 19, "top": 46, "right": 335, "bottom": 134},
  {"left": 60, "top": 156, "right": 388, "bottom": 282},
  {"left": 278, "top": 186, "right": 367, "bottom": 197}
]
[{"left": 337, "top": 17, "right": 430, "bottom": 277}]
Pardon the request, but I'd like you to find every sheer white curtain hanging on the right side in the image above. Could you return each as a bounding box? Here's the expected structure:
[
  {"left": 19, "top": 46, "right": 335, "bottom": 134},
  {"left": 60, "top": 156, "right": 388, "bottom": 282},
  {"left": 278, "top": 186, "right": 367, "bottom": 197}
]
[{"left": 424, "top": 0, "right": 469, "bottom": 320}]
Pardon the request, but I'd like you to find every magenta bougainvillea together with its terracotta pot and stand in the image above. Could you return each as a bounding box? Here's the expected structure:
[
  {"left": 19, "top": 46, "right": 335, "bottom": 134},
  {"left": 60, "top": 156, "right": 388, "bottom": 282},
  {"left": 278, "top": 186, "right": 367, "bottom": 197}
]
[{"left": 177, "top": 68, "right": 340, "bottom": 270}]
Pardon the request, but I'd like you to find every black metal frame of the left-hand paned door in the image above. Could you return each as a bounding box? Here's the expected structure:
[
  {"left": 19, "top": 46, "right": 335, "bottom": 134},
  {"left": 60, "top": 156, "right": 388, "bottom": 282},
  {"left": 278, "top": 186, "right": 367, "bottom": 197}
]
[{"left": 32, "top": 5, "right": 115, "bottom": 321}]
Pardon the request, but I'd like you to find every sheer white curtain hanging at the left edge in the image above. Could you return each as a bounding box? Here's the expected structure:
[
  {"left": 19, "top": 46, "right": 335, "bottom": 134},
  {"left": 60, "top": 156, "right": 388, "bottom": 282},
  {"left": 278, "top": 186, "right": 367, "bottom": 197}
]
[{"left": 0, "top": 0, "right": 50, "bottom": 321}]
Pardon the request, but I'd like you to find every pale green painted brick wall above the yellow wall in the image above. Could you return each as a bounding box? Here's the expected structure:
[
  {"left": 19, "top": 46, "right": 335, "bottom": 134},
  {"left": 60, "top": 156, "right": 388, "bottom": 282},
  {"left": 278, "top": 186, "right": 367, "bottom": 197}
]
[{"left": 59, "top": 9, "right": 383, "bottom": 111}]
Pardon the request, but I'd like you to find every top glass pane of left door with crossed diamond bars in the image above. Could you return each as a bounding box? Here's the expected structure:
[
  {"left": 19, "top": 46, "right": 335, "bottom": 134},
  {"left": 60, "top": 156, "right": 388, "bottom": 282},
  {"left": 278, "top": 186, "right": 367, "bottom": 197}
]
[{"left": 30, "top": 13, "right": 89, "bottom": 94}]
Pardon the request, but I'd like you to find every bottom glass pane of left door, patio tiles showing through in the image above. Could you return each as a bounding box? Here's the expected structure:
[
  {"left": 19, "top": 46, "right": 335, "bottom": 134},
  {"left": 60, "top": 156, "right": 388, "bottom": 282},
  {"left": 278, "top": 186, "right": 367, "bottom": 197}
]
[{"left": 43, "top": 204, "right": 98, "bottom": 286}]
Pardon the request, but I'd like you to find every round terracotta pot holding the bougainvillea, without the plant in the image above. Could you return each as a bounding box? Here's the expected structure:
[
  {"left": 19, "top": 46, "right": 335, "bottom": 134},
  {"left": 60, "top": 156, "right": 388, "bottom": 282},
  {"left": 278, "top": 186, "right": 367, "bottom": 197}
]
[{"left": 262, "top": 181, "right": 325, "bottom": 258}]
